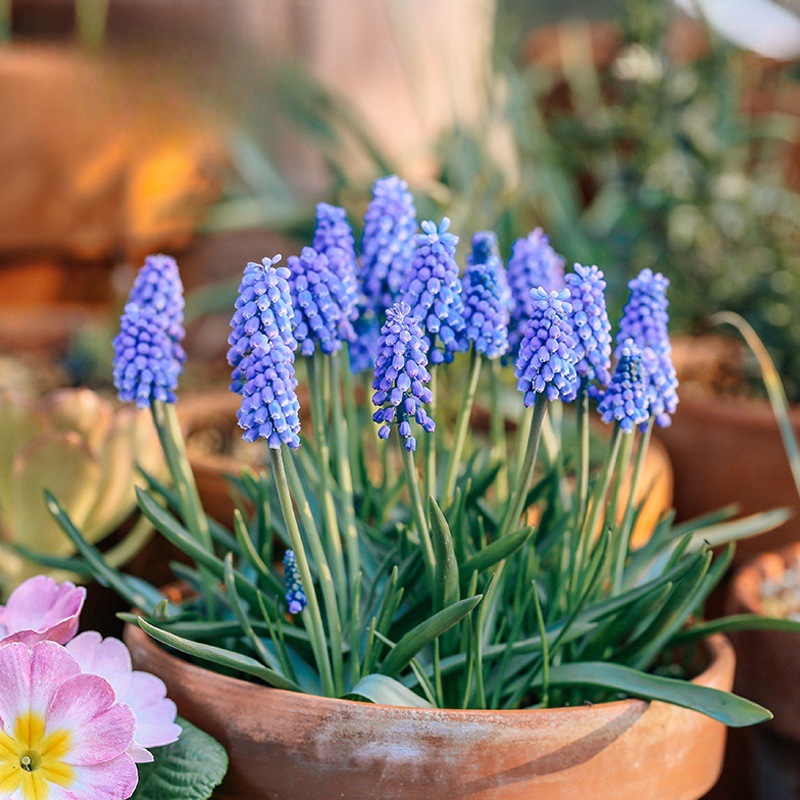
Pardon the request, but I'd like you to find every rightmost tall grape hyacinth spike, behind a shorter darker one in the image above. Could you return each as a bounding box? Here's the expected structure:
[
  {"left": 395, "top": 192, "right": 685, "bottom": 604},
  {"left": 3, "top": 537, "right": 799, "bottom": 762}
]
[{"left": 617, "top": 269, "right": 678, "bottom": 427}]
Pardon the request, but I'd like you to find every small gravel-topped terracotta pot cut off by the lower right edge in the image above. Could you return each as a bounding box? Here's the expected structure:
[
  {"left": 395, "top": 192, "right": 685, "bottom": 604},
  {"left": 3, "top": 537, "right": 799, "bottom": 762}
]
[{"left": 729, "top": 543, "right": 800, "bottom": 800}]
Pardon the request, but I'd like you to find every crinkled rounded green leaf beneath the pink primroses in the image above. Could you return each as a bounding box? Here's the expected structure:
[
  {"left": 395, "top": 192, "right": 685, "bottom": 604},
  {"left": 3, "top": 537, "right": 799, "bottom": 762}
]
[{"left": 131, "top": 717, "right": 228, "bottom": 800}]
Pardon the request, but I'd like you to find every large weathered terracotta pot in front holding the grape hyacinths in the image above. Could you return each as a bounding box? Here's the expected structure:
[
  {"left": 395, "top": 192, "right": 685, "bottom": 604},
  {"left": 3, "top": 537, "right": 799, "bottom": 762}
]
[{"left": 125, "top": 627, "right": 735, "bottom": 800}]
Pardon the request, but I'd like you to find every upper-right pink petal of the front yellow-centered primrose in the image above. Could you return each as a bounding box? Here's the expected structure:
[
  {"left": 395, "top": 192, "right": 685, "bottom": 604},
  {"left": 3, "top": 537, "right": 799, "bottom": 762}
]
[{"left": 46, "top": 672, "right": 136, "bottom": 765}]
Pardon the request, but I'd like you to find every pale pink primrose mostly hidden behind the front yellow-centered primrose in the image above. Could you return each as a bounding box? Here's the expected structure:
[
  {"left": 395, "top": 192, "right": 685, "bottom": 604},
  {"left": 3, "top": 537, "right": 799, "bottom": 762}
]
[{"left": 67, "top": 631, "right": 181, "bottom": 763}]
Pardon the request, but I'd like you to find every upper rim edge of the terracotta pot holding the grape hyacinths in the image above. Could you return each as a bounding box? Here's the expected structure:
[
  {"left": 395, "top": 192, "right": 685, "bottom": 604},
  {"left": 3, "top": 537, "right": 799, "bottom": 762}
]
[{"left": 124, "top": 623, "right": 736, "bottom": 722}]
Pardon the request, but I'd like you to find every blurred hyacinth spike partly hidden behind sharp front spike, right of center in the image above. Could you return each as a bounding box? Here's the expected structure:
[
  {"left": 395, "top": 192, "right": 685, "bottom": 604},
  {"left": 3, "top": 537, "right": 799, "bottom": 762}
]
[{"left": 507, "top": 228, "right": 564, "bottom": 354}]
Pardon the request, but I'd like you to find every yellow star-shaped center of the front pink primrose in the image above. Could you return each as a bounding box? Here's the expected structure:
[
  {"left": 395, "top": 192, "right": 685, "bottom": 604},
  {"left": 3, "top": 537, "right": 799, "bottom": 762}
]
[{"left": 0, "top": 711, "right": 75, "bottom": 800}]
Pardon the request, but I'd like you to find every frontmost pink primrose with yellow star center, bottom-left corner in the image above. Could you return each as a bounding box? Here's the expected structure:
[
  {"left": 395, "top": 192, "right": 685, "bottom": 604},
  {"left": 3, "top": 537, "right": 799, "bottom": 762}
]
[{"left": 0, "top": 641, "right": 138, "bottom": 800}]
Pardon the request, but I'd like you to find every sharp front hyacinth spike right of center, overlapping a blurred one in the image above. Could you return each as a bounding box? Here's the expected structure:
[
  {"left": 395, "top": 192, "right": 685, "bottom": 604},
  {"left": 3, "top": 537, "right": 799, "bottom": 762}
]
[{"left": 514, "top": 287, "right": 577, "bottom": 407}]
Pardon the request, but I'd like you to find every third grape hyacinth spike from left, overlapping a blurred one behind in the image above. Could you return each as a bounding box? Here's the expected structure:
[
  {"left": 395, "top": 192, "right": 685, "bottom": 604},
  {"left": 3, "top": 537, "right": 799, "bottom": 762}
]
[{"left": 289, "top": 247, "right": 352, "bottom": 356}]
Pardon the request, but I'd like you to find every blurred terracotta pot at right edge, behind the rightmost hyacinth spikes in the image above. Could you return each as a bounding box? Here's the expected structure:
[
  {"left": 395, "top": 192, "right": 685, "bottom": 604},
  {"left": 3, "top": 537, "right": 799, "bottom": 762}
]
[{"left": 658, "top": 339, "right": 800, "bottom": 563}]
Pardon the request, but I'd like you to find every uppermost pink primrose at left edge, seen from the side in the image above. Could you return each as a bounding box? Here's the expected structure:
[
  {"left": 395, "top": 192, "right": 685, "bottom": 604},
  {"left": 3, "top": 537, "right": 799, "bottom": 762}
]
[{"left": 0, "top": 575, "right": 86, "bottom": 646}]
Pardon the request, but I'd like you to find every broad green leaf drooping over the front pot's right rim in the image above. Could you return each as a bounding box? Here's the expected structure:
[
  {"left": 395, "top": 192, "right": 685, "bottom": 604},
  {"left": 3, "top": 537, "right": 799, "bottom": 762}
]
[{"left": 535, "top": 661, "right": 772, "bottom": 728}]
